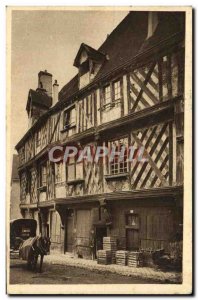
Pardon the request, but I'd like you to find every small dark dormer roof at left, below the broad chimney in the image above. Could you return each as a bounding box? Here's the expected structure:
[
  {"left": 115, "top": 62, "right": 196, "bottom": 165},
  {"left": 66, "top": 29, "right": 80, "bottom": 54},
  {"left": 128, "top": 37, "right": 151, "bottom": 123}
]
[{"left": 26, "top": 89, "right": 52, "bottom": 112}]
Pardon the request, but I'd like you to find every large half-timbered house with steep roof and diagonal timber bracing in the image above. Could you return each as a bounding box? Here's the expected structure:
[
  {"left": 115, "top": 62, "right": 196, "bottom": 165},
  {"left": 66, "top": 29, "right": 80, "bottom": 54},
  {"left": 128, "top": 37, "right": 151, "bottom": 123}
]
[{"left": 16, "top": 12, "right": 185, "bottom": 258}]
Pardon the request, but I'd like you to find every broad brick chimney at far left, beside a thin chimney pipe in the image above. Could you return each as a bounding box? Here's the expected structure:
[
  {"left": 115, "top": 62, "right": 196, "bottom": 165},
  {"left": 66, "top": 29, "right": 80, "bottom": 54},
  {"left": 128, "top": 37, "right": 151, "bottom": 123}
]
[{"left": 38, "top": 70, "right": 52, "bottom": 97}]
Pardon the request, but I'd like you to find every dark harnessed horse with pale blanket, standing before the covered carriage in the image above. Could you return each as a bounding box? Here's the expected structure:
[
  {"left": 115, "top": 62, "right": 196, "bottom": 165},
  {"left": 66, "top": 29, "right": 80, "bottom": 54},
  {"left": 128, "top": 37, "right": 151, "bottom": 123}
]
[{"left": 19, "top": 236, "right": 51, "bottom": 273}]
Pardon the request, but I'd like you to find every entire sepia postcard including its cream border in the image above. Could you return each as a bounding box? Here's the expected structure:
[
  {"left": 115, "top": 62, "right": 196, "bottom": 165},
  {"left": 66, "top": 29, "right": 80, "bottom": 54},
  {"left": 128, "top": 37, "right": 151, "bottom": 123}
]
[{"left": 6, "top": 6, "right": 193, "bottom": 295}]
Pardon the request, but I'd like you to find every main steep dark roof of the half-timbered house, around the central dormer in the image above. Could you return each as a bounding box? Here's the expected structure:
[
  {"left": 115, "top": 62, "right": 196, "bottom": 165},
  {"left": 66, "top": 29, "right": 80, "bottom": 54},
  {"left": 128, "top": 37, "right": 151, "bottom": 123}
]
[{"left": 59, "top": 11, "right": 185, "bottom": 100}]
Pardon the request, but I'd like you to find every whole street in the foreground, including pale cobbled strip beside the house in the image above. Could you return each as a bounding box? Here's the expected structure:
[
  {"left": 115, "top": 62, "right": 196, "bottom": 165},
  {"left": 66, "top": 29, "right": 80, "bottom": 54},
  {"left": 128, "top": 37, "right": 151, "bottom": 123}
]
[{"left": 10, "top": 254, "right": 181, "bottom": 284}]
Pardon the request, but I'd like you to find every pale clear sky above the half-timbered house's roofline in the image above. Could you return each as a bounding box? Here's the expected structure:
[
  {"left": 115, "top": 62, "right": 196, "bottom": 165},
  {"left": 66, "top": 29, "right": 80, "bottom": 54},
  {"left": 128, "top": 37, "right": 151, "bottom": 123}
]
[{"left": 11, "top": 10, "right": 128, "bottom": 157}]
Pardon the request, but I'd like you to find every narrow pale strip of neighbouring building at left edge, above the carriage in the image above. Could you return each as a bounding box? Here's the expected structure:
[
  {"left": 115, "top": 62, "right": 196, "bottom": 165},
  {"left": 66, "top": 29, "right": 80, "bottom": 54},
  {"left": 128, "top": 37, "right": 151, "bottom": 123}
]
[{"left": 10, "top": 154, "right": 21, "bottom": 220}]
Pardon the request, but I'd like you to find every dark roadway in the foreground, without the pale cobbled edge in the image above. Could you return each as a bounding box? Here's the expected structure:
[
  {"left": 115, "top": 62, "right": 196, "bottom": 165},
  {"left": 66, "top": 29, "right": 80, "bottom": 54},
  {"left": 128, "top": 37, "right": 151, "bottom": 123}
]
[{"left": 10, "top": 256, "right": 164, "bottom": 284}]
